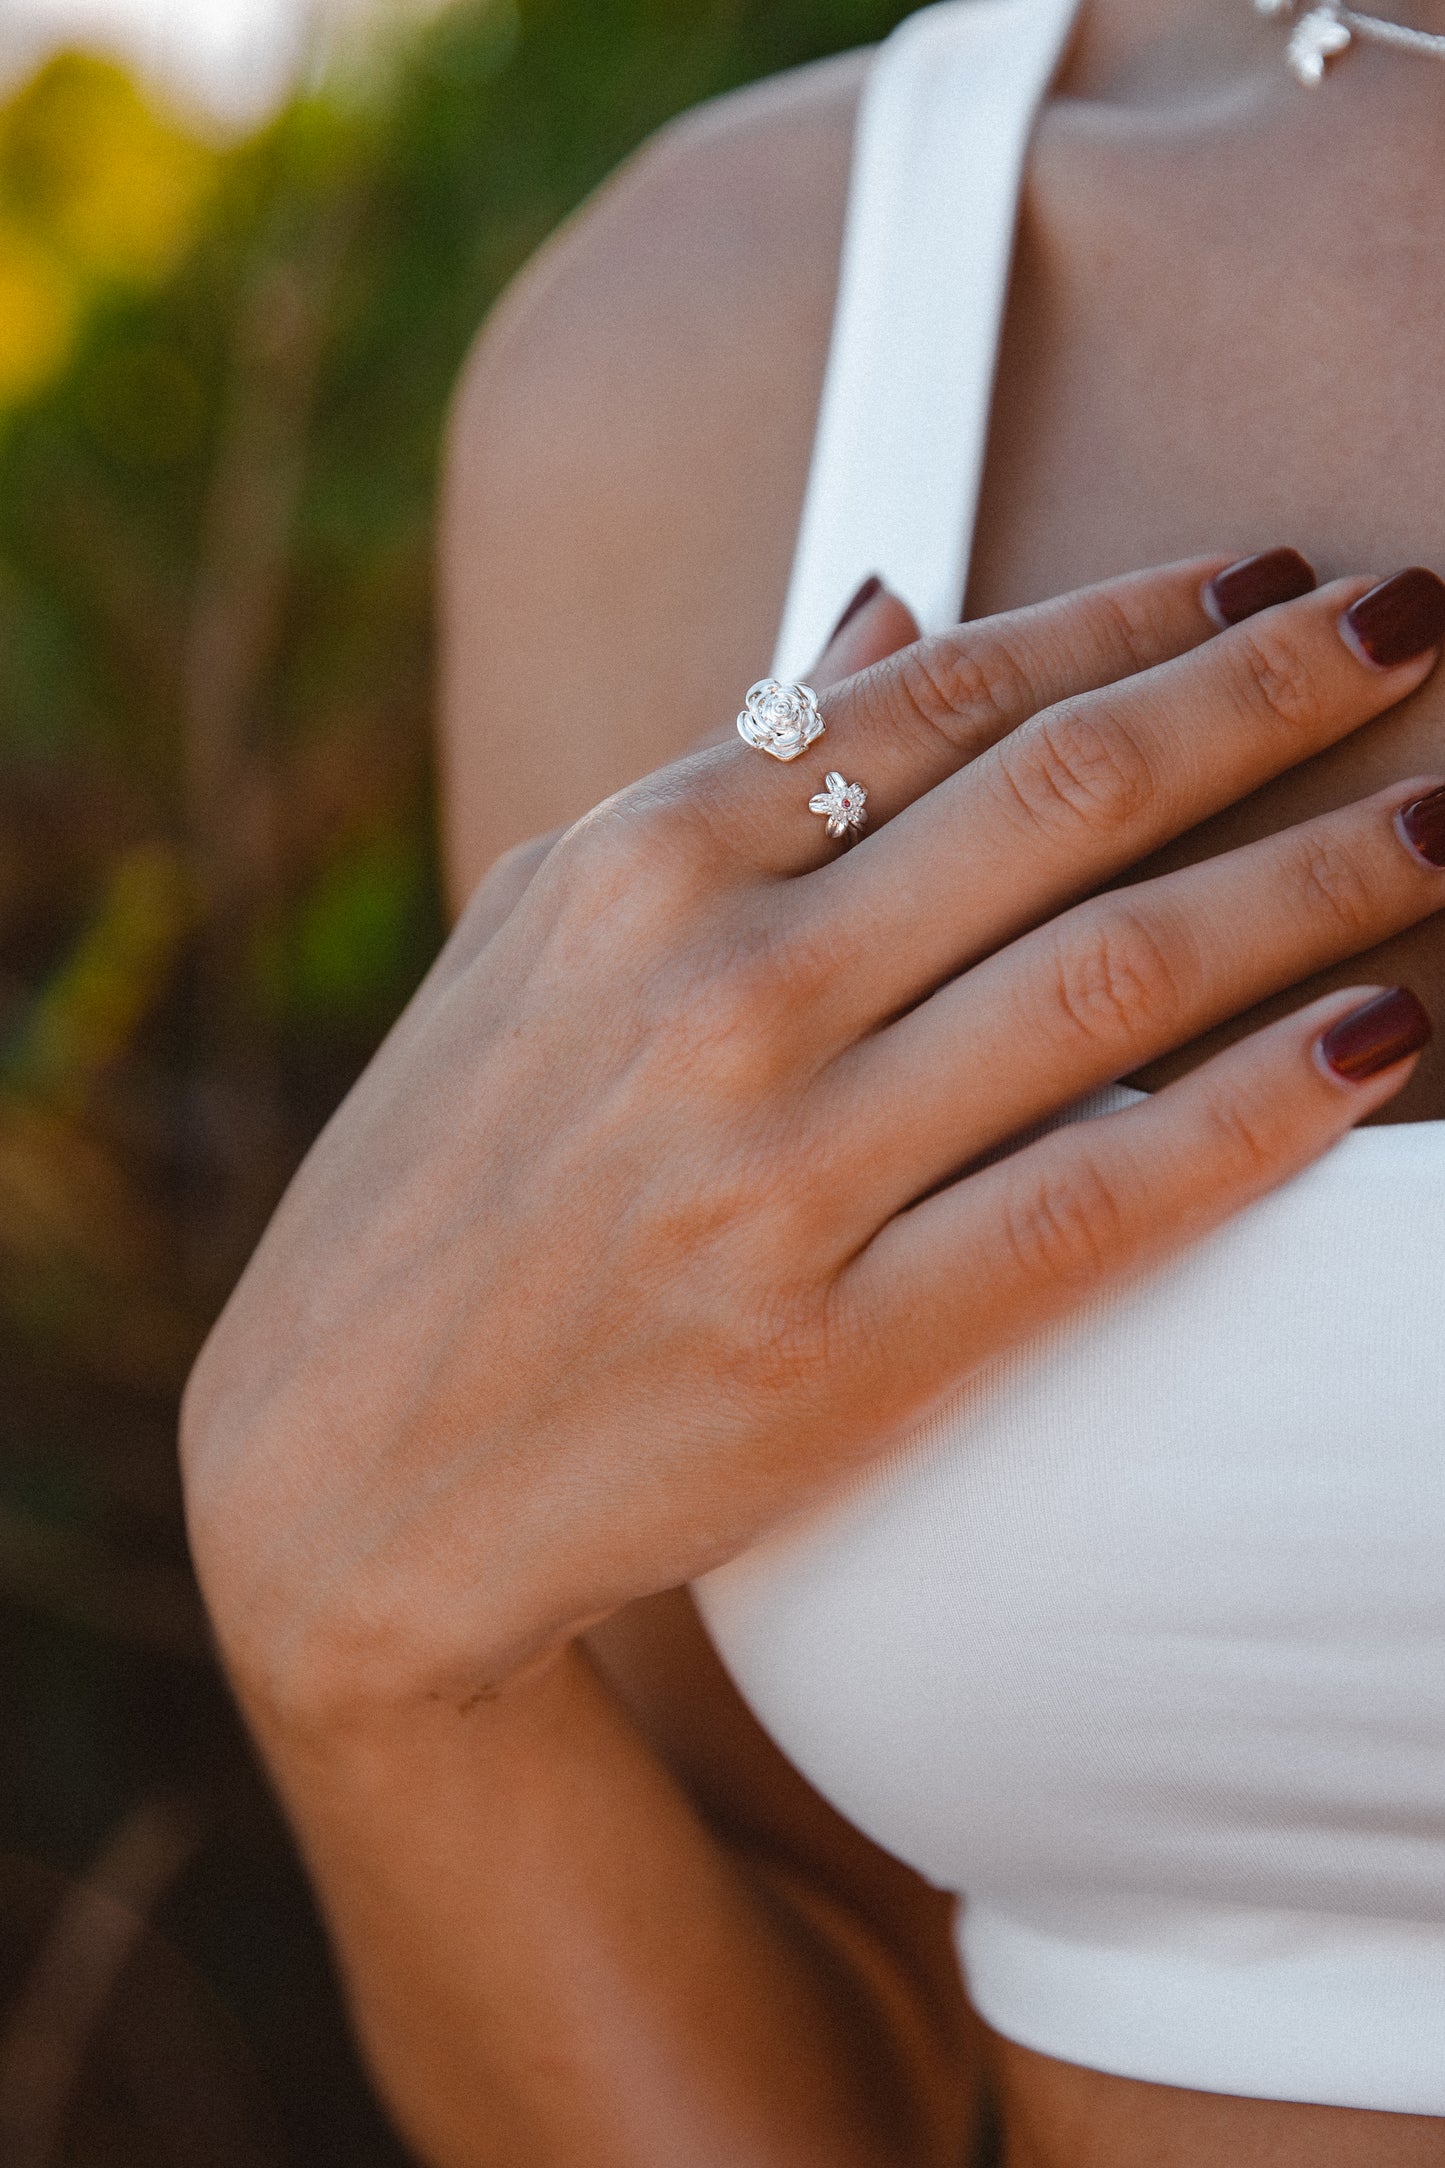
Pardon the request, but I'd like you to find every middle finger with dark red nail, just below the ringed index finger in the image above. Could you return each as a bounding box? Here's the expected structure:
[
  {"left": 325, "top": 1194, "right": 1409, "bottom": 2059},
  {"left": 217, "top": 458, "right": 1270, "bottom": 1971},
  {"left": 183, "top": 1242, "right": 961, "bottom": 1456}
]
[{"left": 793, "top": 572, "right": 1445, "bottom": 1041}]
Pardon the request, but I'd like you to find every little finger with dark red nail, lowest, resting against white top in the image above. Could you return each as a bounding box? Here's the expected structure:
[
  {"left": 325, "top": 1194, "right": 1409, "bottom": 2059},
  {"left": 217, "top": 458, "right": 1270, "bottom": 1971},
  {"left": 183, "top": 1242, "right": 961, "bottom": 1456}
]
[{"left": 832, "top": 986, "right": 1430, "bottom": 1435}]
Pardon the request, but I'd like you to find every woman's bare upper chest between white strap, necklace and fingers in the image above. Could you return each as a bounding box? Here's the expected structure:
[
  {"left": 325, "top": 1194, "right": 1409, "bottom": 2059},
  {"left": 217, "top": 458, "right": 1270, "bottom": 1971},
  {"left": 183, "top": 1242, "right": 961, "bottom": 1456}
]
[{"left": 968, "top": 82, "right": 1445, "bottom": 1121}]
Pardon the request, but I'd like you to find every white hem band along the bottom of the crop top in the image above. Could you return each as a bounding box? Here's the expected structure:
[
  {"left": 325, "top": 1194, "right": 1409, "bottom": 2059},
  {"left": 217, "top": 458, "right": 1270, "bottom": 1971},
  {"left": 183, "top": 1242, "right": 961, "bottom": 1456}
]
[{"left": 960, "top": 1897, "right": 1445, "bottom": 2116}]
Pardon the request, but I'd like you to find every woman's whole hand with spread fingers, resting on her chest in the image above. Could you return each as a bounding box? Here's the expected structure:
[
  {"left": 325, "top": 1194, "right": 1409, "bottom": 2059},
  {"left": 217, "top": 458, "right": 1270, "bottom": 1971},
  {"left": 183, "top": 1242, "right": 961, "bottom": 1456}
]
[{"left": 184, "top": 562, "right": 1445, "bottom": 1732}]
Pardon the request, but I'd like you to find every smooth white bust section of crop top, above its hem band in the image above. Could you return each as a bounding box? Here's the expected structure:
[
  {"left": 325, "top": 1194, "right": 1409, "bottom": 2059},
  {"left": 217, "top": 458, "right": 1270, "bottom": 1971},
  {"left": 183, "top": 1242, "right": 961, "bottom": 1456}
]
[{"left": 698, "top": 1130, "right": 1445, "bottom": 1923}]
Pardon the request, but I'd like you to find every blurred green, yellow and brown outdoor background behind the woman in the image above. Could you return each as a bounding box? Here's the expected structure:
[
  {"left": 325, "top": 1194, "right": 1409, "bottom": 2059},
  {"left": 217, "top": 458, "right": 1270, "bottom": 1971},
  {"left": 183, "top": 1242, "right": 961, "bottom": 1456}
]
[{"left": 0, "top": 0, "right": 908, "bottom": 2168}]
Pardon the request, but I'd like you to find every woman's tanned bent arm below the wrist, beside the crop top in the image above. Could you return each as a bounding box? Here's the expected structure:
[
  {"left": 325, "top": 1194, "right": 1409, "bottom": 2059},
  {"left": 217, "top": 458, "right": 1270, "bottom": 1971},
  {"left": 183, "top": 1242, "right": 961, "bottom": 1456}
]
[{"left": 258, "top": 1650, "right": 962, "bottom": 2168}]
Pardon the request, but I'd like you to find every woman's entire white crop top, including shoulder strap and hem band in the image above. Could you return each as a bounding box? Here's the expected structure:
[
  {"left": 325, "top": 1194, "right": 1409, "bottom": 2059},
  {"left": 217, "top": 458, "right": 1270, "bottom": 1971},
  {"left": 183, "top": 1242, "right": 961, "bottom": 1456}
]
[{"left": 695, "top": 0, "right": 1445, "bottom": 2116}]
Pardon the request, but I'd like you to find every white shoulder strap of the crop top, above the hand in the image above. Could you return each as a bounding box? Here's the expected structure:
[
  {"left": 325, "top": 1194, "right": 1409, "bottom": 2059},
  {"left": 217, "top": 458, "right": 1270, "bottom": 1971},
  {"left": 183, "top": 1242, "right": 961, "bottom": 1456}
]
[{"left": 773, "top": 0, "right": 1079, "bottom": 679}]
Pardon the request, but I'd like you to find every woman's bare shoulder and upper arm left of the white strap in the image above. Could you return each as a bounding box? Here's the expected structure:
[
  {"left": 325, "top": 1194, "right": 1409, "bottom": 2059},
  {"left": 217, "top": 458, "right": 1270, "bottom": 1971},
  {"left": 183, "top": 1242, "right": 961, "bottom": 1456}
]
[{"left": 442, "top": 54, "right": 867, "bottom": 895}]
